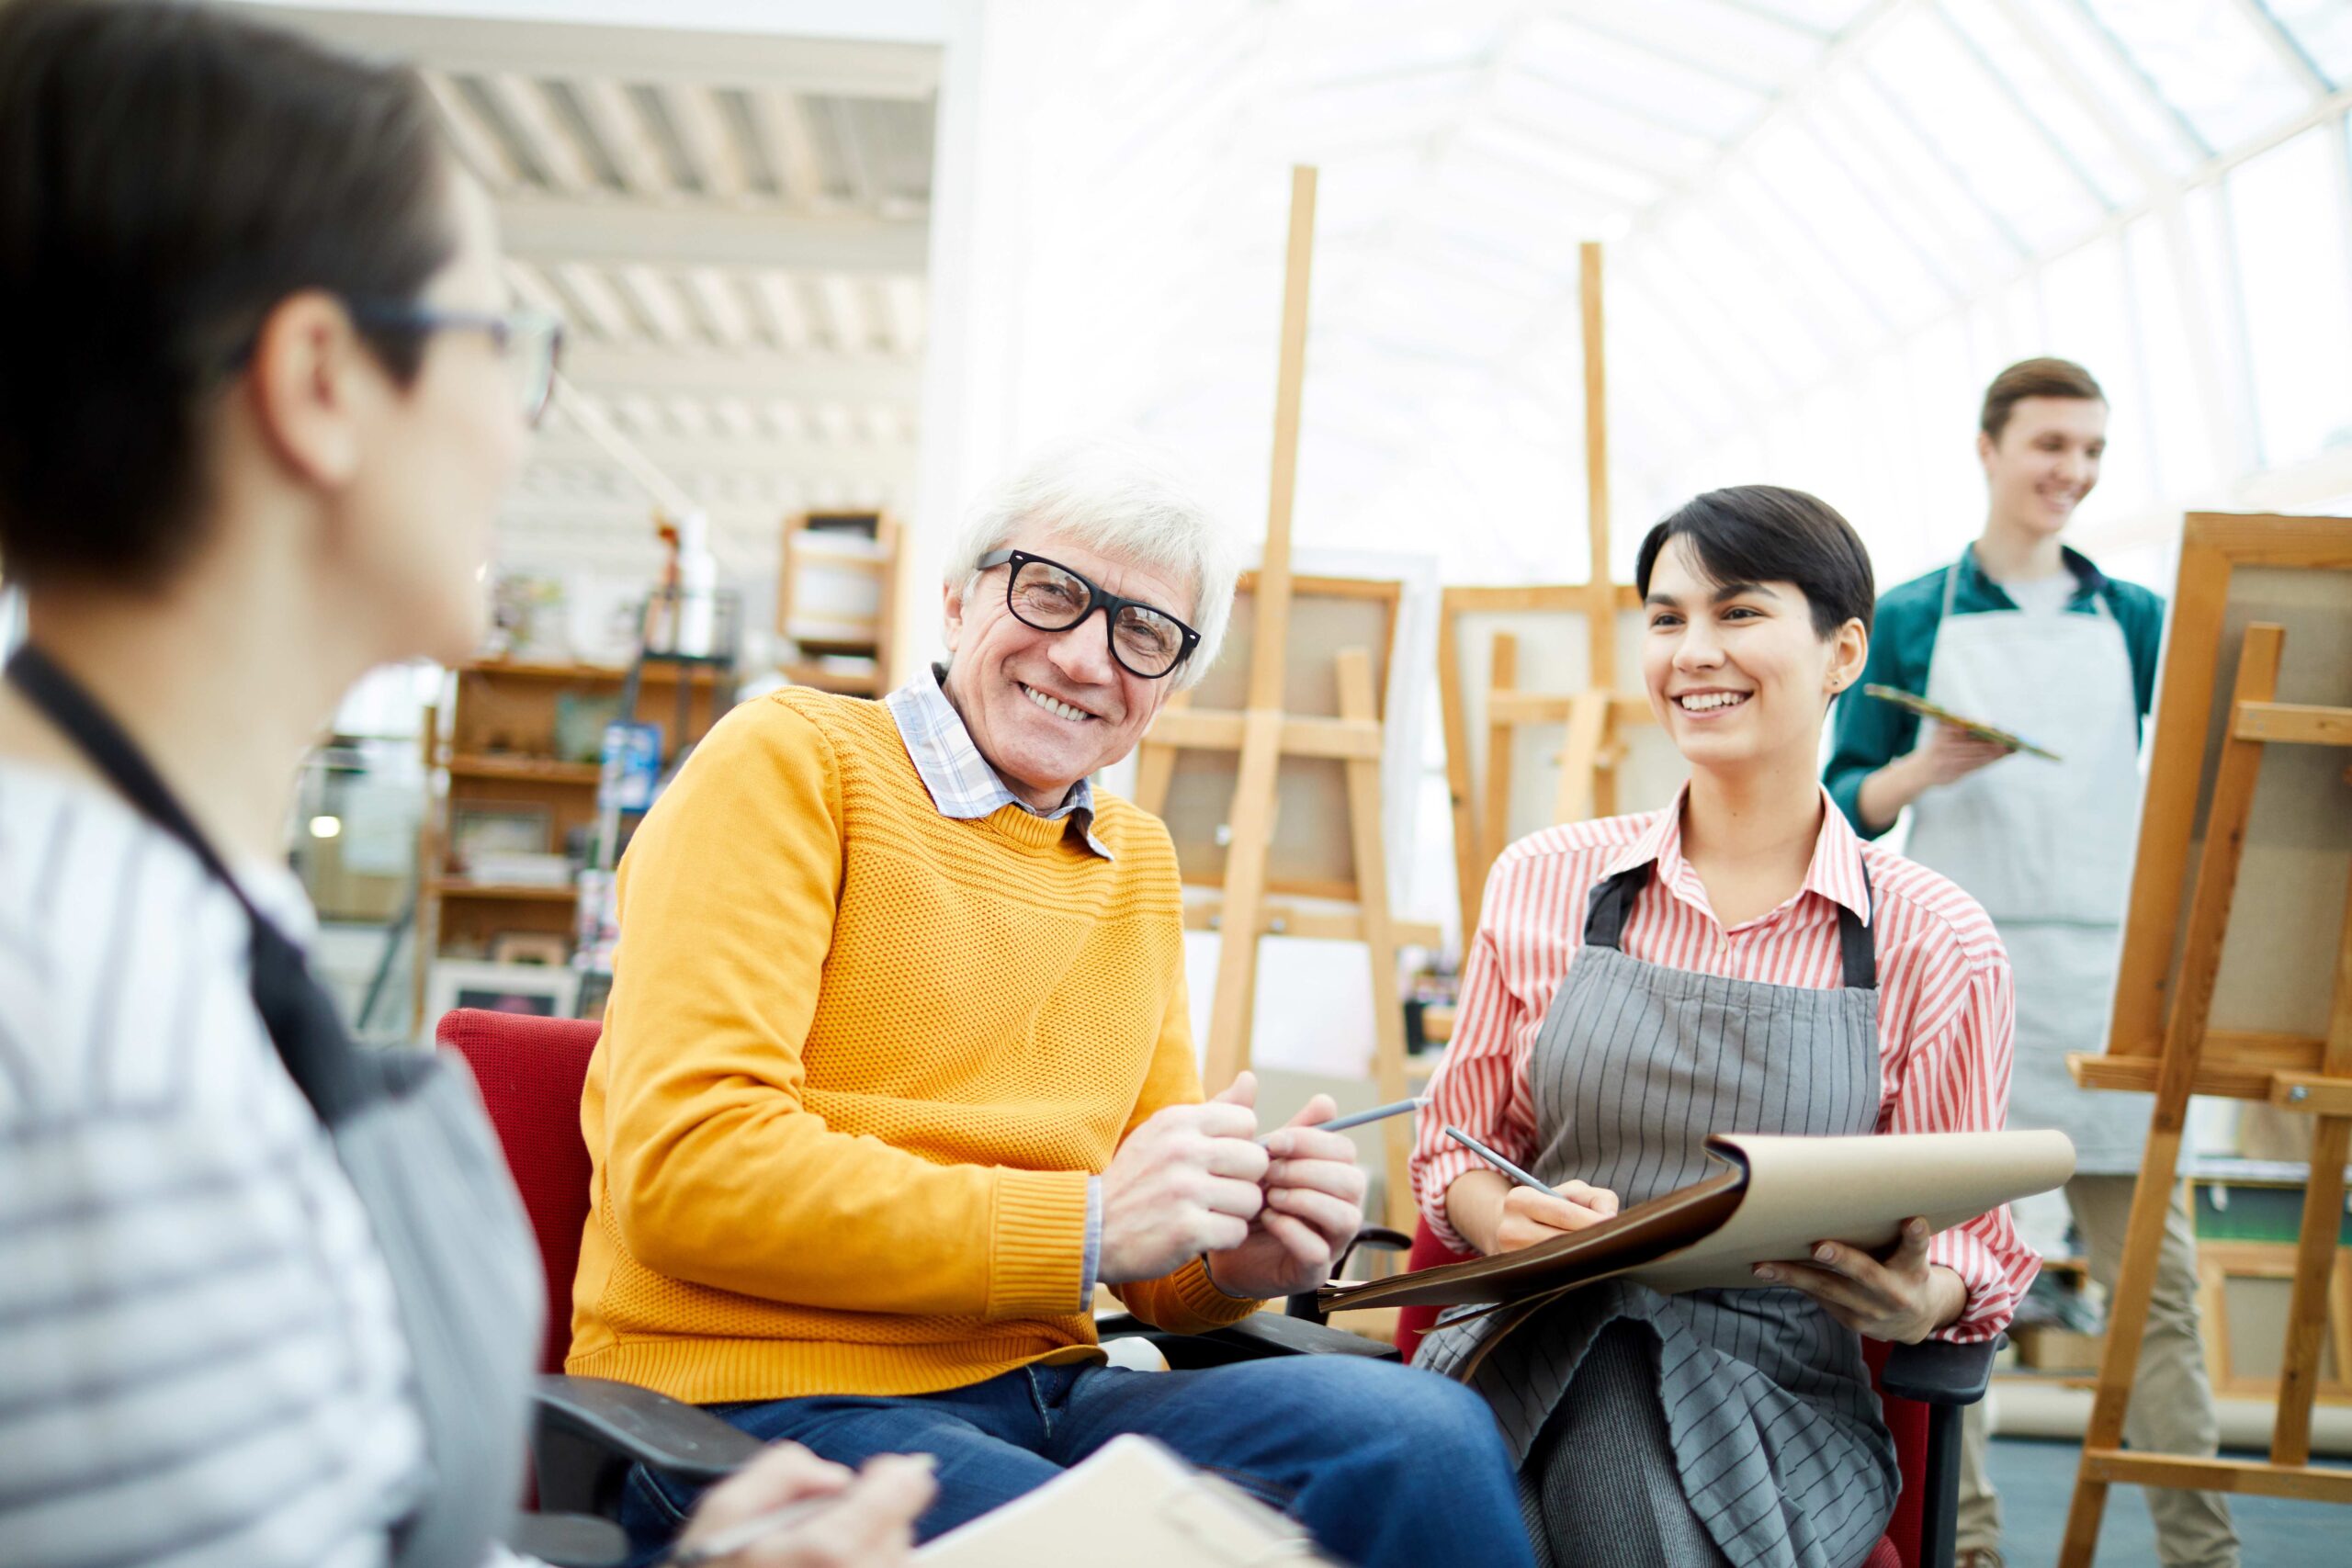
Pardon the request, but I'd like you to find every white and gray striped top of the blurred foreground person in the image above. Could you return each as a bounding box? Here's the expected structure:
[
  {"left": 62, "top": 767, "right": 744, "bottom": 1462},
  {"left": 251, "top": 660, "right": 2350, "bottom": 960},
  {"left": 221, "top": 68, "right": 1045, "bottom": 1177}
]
[{"left": 0, "top": 761, "right": 460, "bottom": 1568}]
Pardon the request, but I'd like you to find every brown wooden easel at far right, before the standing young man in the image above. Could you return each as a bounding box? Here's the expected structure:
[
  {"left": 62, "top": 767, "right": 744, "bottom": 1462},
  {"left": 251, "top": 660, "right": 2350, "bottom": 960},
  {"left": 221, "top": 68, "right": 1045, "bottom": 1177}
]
[{"left": 2058, "top": 514, "right": 2352, "bottom": 1568}]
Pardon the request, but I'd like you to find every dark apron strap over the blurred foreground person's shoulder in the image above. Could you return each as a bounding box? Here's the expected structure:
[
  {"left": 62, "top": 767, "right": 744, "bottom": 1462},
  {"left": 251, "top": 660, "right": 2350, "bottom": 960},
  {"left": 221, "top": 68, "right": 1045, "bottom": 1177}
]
[{"left": 7, "top": 644, "right": 377, "bottom": 1126}]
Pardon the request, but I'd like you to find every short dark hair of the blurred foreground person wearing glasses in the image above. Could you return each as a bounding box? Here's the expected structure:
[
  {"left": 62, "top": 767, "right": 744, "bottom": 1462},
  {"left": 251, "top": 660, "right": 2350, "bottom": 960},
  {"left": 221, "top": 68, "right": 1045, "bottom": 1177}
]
[{"left": 0, "top": 0, "right": 457, "bottom": 588}]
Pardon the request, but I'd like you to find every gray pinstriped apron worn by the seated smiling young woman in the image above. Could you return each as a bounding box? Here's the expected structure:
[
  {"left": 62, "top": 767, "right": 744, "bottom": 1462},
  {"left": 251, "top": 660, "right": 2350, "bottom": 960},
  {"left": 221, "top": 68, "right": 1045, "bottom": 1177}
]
[{"left": 1416, "top": 863, "right": 1898, "bottom": 1568}]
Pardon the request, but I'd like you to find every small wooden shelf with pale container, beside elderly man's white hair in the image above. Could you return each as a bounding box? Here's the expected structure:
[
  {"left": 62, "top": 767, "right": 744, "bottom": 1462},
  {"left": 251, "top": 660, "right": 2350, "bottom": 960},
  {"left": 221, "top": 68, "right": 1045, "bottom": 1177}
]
[{"left": 776, "top": 513, "right": 903, "bottom": 696}]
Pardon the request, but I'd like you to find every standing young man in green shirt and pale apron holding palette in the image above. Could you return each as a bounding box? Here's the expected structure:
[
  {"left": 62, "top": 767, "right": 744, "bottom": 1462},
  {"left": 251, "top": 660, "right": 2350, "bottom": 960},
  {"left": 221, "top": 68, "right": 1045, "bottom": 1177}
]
[{"left": 1827, "top": 360, "right": 2237, "bottom": 1568}]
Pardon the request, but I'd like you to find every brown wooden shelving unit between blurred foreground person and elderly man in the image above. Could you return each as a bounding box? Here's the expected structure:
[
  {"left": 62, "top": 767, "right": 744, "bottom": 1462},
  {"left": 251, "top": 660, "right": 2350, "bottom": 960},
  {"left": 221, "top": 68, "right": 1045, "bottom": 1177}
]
[{"left": 412, "top": 659, "right": 734, "bottom": 1030}]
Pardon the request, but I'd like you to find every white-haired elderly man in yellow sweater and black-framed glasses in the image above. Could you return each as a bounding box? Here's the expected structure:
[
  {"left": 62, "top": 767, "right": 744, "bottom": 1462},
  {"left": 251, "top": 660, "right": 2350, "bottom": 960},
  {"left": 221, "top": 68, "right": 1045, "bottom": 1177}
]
[{"left": 567, "top": 442, "right": 1529, "bottom": 1568}]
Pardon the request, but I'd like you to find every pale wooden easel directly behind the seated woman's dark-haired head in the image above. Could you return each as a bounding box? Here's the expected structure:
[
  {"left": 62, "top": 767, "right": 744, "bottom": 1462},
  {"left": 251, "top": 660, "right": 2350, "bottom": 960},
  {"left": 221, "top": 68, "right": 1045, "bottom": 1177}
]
[{"left": 1437, "top": 240, "right": 1656, "bottom": 945}]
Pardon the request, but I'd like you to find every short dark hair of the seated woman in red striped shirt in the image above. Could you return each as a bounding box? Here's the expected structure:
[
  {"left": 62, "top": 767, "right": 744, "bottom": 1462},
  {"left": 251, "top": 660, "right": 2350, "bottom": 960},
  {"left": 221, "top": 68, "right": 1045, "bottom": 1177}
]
[{"left": 1633, "top": 484, "right": 1877, "bottom": 637}]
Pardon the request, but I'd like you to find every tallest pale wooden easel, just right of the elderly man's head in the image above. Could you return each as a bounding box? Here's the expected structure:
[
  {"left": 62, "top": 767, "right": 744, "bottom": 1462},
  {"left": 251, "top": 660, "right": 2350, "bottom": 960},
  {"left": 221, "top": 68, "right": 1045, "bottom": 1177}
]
[{"left": 1136, "top": 167, "right": 1435, "bottom": 1229}]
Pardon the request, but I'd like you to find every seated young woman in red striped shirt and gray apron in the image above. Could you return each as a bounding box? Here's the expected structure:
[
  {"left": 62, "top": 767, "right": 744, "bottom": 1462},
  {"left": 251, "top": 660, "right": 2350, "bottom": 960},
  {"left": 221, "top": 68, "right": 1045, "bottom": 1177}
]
[{"left": 1414, "top": 484, "right": 2034, "bottom": 1568}]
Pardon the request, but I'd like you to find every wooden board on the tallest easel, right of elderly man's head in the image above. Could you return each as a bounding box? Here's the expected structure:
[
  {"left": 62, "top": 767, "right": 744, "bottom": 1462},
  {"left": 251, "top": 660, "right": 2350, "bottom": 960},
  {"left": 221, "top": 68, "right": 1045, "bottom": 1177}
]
[{"left": 1159, "top": 573, "right": 1404, "bottom": 900}]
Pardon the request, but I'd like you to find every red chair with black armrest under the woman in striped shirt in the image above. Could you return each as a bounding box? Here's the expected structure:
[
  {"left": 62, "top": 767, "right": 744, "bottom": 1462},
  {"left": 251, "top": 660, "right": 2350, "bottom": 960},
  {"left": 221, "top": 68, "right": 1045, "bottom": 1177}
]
[{"left": 1397, "top": 1220, "right": 1995, "bottom": 1568}]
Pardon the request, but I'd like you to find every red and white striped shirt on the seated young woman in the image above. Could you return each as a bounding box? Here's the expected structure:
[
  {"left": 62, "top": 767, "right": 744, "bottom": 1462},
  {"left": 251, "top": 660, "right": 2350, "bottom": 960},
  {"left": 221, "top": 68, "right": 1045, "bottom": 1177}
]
[{"left": 1414, "top": 792, "right": 2041, "bottom": 1340}]
